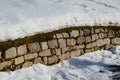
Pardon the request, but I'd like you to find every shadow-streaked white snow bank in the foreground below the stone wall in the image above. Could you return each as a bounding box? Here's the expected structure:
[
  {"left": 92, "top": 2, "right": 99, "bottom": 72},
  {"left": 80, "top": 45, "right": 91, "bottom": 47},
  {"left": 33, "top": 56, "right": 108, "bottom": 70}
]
[{"left": 0, "top": 46, "right": 120, "bottom": 80}]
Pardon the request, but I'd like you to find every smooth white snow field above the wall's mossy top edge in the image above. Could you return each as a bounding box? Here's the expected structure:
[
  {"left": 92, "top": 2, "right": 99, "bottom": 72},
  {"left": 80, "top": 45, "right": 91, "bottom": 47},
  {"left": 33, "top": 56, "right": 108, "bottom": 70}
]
[{"left": 0, "top": 0, "right": 120, "bottom": 41}]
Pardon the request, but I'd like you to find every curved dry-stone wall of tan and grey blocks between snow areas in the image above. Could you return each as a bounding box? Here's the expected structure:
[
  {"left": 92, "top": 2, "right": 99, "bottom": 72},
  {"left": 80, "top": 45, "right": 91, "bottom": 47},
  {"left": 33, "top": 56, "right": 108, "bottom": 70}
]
[{"left": 0, "top": 27, "right": 120, "bottom": 71}]
